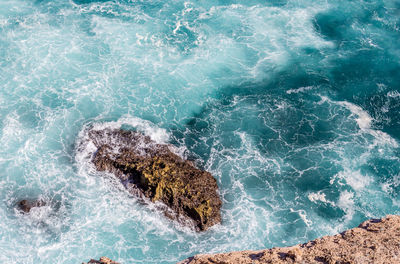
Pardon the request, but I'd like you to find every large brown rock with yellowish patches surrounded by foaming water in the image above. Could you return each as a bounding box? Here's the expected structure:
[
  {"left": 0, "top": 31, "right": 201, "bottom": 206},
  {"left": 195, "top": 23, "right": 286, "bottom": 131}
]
[{"left": 88, "top": 129, "right": 221, "bottom": 230}]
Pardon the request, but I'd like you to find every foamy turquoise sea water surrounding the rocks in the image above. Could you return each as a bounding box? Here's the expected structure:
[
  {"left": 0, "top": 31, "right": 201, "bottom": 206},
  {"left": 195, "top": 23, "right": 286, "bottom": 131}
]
[{"left": 0, "top": 0, "right": 400, "bottom": 264}]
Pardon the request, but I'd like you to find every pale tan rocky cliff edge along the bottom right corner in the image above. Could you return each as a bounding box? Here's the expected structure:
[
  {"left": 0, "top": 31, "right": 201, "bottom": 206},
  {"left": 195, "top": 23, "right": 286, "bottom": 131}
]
[{"left": 178, "top": 215, "right": 400, "bottom": 264}]
